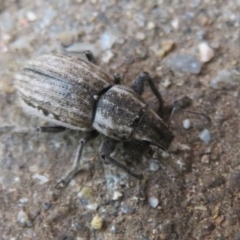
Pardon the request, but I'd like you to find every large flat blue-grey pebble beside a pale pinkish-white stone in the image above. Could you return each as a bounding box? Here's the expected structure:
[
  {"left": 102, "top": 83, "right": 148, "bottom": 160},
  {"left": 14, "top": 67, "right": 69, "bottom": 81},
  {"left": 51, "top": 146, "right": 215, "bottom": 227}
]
[{"left": 166, "top": 54, "right": 202, "bottom": 74}]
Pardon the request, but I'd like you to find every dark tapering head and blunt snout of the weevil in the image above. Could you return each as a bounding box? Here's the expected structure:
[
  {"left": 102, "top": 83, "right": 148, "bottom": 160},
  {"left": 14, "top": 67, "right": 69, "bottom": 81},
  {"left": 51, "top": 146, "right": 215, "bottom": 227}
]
[{"left": 133, "top": 108, "right": 174, "bottom": 150}]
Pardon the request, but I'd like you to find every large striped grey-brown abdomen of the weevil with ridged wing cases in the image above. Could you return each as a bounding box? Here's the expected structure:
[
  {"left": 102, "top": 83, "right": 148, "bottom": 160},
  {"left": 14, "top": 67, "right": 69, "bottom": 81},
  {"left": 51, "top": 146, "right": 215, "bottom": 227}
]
[{"left": 17, "top": 55, "right": 114, "bottom": 130}]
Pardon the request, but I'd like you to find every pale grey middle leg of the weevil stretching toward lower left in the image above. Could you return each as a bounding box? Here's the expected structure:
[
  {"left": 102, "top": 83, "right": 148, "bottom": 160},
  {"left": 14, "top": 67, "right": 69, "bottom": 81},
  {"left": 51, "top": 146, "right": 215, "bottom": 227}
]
[{"left": 55, "top": 130, "right": 98, "bottom": 189}]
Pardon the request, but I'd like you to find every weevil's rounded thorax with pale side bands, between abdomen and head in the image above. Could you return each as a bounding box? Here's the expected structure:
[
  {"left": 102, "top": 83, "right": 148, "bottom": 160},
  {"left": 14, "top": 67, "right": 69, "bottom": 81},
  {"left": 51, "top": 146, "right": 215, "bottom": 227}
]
[{"left": 93, "top": 85, "right": 147, "bottom": 141}]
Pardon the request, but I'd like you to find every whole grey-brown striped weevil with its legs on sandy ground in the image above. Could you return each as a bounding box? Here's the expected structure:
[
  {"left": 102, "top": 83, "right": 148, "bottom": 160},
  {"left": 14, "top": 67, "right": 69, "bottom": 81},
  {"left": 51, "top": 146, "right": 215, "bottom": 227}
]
[{"left": 17, "top": 51, "right": 174, "bottom": 187}]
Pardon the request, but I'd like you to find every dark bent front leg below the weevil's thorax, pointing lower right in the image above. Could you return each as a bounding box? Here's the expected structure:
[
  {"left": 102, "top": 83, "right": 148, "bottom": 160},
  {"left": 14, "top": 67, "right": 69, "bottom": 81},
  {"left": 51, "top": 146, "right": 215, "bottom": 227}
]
[{"left": 101, "top": 139, "right": 143, "bottom": 180}]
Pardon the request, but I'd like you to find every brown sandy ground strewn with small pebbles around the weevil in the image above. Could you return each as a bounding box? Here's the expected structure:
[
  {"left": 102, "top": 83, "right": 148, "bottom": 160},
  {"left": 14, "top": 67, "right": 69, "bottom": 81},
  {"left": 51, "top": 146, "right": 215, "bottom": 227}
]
[{"left": 0, "top": 0, "right": 240, "bottom": 240}]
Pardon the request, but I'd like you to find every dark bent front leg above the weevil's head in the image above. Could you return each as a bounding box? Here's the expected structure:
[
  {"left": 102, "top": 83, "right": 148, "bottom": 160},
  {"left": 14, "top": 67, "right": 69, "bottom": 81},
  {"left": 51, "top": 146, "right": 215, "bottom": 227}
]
[{"left": 131, "top": 72, "right": 163, "bottom": 116}]
